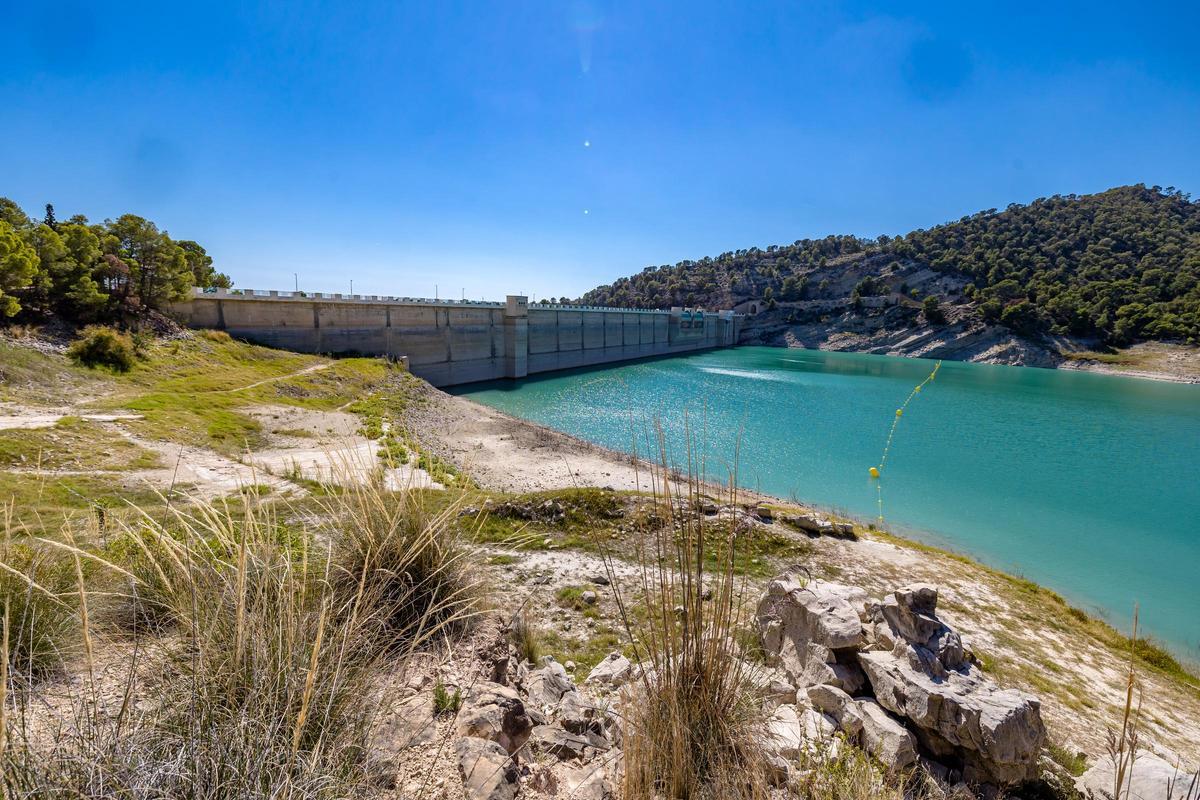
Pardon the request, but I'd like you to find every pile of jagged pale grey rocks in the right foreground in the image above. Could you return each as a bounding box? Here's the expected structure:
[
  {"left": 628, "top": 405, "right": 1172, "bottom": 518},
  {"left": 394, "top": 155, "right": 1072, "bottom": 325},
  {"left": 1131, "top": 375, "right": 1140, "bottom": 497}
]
[{"left": 757, "top": 571, "right": 1046, "bottom": 787}]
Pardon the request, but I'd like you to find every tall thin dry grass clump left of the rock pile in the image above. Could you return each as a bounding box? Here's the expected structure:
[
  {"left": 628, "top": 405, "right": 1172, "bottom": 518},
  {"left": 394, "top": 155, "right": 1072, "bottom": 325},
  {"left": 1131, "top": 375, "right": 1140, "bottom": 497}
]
[{"left": 610, "top": 422, "right": 769, "bottom": 800}]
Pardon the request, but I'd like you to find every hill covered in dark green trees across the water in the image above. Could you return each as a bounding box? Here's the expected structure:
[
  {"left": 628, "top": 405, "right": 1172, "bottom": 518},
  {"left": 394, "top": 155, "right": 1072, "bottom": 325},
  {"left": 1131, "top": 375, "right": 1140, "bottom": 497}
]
[{"left": 581, "top": 185, "right": 1200, "bottom": 344}]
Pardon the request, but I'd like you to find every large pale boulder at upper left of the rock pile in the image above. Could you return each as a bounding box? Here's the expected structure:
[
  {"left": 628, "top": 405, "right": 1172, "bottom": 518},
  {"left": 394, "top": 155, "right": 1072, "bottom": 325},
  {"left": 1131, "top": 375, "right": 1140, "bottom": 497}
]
[{"left": 756, "top": 570, "right": 866, "bottom": 686}]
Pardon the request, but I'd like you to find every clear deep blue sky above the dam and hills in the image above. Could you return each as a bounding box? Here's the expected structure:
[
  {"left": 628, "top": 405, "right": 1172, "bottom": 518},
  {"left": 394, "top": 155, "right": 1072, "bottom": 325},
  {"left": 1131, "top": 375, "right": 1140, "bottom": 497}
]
[{"left": 0, "top": 0, "right": 1200, "bottom": 297}]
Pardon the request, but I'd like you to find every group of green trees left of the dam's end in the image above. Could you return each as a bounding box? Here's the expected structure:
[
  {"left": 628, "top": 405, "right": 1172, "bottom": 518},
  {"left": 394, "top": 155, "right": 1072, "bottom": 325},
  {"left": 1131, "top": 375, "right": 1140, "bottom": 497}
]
[{"left": 0, "top": 198, "right": 230, "bottom": 321}]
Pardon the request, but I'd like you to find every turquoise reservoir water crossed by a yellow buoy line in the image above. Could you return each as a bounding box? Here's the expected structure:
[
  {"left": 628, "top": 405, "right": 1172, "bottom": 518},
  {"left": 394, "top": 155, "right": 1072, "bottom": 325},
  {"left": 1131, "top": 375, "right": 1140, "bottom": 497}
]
[{"left": 457, "top": 347, "right": 1200, "bottom": 660}]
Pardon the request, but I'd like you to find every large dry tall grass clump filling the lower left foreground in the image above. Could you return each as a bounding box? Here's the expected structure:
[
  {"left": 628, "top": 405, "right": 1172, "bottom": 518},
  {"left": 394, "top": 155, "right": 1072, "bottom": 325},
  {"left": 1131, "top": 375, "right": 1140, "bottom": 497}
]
[{"left": 0, "top": 472, "right": 473, "bottom": 799}]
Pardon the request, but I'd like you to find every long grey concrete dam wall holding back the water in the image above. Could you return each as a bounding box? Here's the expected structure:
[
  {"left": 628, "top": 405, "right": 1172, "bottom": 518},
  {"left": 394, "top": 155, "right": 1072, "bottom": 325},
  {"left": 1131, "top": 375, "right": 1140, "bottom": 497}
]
[{"left": 173, "top": 289, "right": 744, "bottom": 386}]
